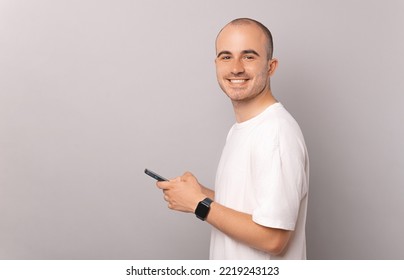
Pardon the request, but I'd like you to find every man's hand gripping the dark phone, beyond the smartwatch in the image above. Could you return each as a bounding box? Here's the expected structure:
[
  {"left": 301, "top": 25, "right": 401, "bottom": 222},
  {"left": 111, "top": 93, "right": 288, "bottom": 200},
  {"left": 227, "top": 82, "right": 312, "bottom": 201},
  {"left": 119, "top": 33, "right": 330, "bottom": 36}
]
[{"left": 156, "top": 172, "right": 206, "bottom": 213}]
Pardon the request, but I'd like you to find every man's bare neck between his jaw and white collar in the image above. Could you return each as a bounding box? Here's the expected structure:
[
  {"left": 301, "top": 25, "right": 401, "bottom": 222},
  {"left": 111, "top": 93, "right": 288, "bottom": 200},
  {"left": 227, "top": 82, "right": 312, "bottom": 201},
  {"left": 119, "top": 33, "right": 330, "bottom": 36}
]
[{"left": 232, "top": 90, "right": 278, "bottom": 123}]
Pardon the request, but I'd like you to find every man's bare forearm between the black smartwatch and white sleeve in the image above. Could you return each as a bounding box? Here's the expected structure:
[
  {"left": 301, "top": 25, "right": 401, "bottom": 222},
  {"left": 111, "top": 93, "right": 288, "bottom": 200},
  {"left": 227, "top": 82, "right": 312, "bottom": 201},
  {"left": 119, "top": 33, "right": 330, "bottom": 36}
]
[{"left": 206, "top": 202, "right": 291, "bottom": 255}]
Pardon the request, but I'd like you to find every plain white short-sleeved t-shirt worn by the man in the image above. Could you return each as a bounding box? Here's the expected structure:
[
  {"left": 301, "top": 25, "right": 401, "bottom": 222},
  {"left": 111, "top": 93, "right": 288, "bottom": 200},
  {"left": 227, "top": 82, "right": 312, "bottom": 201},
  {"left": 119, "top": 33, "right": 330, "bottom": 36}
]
[{"left": 210, "top": 103, "right": 309, "bottom": 259}]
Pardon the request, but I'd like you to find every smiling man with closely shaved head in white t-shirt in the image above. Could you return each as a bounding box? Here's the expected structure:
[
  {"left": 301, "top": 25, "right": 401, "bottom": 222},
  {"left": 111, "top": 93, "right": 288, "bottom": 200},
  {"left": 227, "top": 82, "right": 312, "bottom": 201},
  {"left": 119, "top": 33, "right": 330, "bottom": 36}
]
[{"left": 157, "top": 18, "right": 309, "bottom": 259}]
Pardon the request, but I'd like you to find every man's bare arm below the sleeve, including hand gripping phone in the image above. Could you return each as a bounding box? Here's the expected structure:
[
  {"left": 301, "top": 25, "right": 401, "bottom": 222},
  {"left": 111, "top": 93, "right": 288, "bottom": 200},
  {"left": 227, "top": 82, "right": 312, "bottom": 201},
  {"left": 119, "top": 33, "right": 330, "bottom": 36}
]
[{"left": 157, "top": 173, "right": 291, "bottom": 255}]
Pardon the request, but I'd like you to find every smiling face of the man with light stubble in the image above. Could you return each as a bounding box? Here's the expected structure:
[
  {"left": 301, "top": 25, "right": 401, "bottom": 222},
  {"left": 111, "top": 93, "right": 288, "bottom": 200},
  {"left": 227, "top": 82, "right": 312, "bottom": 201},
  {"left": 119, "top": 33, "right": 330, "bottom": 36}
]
[{"left": 215, "top": 24, "right": 272, "bottom": 101}]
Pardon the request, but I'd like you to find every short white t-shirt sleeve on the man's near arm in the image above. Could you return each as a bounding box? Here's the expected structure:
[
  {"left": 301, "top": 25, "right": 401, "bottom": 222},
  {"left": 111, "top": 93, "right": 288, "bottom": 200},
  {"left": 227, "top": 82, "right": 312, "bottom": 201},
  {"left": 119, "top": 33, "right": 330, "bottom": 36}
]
[{"left": 252, "top": 120, "right": 307, "bottom": 230}]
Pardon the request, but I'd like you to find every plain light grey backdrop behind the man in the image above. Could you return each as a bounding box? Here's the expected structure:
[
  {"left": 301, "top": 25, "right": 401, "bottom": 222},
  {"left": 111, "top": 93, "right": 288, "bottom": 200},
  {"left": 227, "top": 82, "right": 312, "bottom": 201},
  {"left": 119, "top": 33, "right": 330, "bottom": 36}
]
[{"left": 0, "top": 0, "right": 404, "bottom": 259}]
